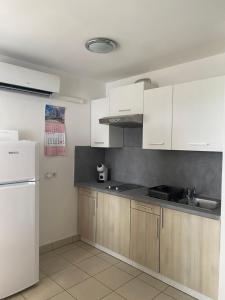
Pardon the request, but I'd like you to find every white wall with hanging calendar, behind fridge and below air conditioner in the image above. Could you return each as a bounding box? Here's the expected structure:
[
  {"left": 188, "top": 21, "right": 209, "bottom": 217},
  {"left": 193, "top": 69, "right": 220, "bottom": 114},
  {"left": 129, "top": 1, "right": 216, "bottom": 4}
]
[{"left": 0, "top": 56, "right": 105, "bottom": 245}]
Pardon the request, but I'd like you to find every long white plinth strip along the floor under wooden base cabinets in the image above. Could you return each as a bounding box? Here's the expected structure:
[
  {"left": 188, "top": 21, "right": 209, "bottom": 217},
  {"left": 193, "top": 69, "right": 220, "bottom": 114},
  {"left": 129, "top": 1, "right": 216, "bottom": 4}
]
[{"left": 81, "top": 238, "right": 213, "bottom": 300}]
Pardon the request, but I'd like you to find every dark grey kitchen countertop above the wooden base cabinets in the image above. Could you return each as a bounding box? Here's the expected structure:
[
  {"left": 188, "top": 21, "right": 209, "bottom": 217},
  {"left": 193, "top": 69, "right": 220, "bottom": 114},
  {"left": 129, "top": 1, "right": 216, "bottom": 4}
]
[{"left": 75, "top": 181, "right": 221, "bottom": 220}]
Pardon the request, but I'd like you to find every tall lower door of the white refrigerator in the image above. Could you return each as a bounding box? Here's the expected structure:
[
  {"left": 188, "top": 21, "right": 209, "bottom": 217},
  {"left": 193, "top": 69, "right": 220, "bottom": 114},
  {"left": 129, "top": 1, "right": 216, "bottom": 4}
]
[{"left": 0, "top": 182, "right": 39, "bottom": 299}]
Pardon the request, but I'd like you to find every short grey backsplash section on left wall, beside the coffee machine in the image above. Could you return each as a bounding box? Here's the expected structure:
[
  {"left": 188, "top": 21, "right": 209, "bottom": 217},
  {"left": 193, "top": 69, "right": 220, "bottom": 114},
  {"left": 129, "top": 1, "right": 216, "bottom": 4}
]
[{"left": 74, "top": 146, "right": 105, "bottom": 182}]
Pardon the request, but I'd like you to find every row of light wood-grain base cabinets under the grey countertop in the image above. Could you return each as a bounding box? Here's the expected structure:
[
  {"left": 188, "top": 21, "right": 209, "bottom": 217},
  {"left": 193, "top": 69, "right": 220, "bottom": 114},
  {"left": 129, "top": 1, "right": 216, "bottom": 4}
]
[{"left": 78, "top": 188, "right": 220, "bottom": 300}]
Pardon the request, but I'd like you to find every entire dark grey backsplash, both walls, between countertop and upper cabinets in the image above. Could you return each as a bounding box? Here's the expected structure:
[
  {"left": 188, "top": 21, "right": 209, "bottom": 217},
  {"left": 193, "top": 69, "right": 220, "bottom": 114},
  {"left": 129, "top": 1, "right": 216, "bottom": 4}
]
[{"left": 75, "top": 128, "right": 222, "bottom": 199}]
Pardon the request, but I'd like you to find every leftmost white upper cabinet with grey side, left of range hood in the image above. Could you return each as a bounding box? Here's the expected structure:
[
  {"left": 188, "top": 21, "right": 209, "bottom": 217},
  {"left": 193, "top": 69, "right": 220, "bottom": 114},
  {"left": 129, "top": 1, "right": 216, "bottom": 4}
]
[{"left": 91, "top": 98, "right": 123, "bottom": 148}]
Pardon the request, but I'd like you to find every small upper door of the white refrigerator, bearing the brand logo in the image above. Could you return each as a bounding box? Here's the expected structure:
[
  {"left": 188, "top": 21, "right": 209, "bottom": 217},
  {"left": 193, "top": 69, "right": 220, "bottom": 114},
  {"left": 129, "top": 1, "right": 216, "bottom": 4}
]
[{"left": 0, "top": 141, "right": 39, "bottom": 184}]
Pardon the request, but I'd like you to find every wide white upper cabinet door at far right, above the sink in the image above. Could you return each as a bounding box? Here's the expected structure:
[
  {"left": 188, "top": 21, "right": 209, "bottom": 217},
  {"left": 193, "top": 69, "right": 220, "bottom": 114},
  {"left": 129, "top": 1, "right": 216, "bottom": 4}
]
[{"left": 172, "top": 77, "right": 225, "bottom": 151}]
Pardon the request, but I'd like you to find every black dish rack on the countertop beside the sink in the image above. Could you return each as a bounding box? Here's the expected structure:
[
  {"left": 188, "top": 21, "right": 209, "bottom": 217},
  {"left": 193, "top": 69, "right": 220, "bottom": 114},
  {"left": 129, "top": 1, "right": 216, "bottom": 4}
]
[{"left": 148, "top": 185, "right": 185, "bottom": 201}]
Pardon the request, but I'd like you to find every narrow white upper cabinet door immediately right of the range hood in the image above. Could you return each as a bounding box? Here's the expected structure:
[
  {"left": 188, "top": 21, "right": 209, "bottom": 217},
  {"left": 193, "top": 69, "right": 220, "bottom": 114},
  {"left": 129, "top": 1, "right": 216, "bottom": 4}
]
[{"left": 143, "top": 86, "right": 173, "bottom": 150}]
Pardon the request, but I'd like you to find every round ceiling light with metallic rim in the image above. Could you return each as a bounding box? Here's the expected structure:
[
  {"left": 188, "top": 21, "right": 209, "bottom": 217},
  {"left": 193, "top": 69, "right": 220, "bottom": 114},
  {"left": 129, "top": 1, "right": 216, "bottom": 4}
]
[{"left": 85, "top": 38, "right": 118, "bottom": 53}]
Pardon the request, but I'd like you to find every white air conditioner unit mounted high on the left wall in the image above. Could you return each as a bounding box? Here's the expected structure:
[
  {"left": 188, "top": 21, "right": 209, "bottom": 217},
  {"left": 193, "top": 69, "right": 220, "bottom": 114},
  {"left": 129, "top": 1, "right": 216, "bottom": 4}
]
[{"left": 0, "top": 62, "right": 60, "bottom": 97}]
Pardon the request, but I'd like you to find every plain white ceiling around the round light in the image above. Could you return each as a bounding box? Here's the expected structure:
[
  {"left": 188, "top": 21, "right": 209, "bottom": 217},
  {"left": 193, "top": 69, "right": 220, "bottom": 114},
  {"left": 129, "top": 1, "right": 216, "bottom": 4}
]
[{"left": 0, "top": 0, "right": 225, "bottom": 81}]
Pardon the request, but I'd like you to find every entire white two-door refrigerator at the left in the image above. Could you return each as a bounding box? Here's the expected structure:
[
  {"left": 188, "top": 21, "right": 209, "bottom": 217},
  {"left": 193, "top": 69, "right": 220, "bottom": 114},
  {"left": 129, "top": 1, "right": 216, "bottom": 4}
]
[{"left": 0, "top": 141, "right": 39, "bottom": 299}]
